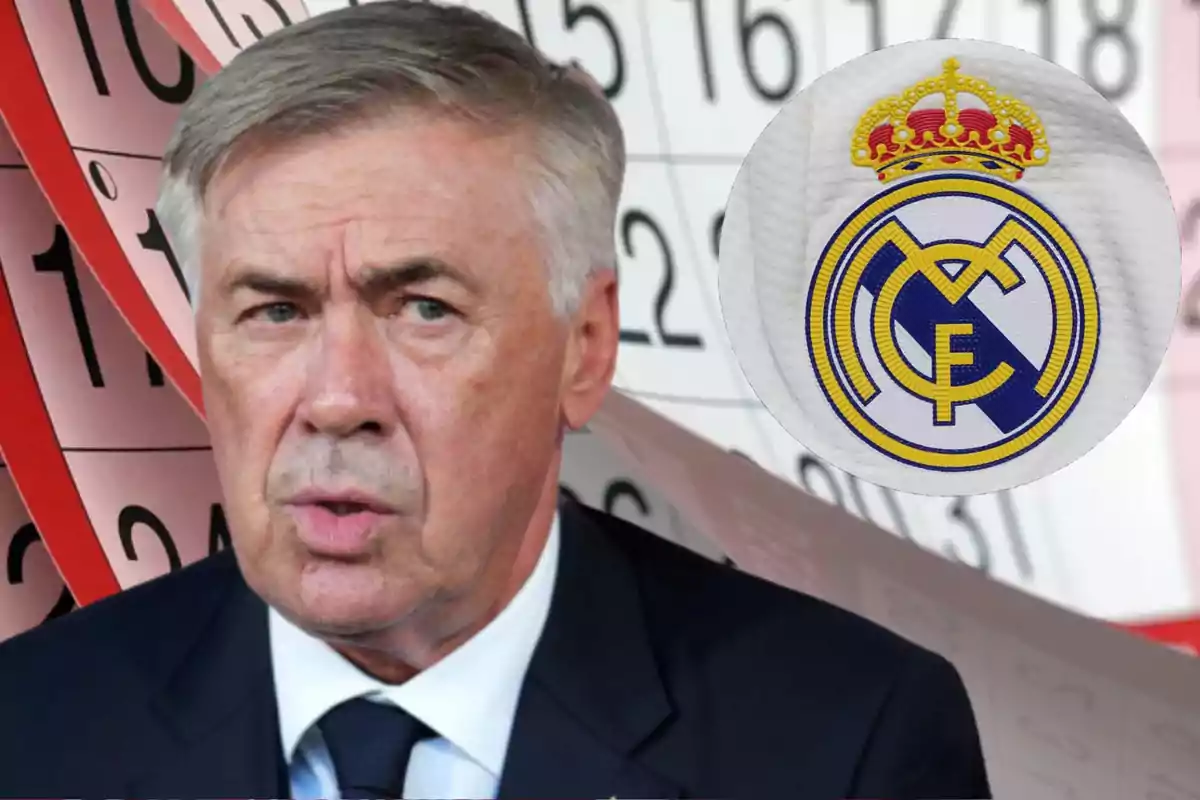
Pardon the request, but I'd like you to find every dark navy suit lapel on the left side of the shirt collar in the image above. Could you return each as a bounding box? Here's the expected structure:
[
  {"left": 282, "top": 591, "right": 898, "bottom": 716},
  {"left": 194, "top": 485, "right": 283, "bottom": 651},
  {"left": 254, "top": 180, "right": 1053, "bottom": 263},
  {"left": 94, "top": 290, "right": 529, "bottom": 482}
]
[{"left": 126, "top": 557, "right": 289, "bottom": 798}]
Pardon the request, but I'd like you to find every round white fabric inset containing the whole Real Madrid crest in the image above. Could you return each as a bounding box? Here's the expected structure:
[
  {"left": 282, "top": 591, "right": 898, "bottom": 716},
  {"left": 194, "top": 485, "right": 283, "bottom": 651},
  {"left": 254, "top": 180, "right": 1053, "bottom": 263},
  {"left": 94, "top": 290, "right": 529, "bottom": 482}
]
[{"left": 720, "top": 40, "right": 1181, "bottom": 495}]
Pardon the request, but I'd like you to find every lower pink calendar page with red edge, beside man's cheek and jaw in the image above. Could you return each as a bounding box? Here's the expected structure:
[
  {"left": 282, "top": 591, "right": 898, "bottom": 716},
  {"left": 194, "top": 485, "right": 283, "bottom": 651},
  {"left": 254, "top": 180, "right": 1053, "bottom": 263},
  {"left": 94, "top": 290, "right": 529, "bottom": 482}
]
[{"left": 0, "top": 122, "right": 228, "bottom": 592}]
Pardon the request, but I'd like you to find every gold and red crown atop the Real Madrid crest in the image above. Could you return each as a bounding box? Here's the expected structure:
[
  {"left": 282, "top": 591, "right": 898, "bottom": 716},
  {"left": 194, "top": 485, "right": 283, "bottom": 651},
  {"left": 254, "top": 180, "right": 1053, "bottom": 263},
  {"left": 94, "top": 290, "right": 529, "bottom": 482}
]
[{"left": 851, "top": 59, "right": 1050, "bottom": 184}]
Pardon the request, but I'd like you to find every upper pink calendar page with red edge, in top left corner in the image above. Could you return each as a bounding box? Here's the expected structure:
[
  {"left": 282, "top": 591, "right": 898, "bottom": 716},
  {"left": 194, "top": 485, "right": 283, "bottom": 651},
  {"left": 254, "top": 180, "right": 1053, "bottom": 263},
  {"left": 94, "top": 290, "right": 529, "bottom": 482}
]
[{"left": 0, "top": 0, "right": 204, "bottom": 409}]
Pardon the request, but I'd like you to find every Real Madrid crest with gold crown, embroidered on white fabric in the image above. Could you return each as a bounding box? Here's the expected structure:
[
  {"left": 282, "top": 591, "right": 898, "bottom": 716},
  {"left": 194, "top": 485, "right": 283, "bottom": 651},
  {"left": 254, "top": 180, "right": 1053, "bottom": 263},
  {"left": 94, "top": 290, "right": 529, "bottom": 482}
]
[{"left": 805, "top": 58, "right": 1100, "bottom": 469}]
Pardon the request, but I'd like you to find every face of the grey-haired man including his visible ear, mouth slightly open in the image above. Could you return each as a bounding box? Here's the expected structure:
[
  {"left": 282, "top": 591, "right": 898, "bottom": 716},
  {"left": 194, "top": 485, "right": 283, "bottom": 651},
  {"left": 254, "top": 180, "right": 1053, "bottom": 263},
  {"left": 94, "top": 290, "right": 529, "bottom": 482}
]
[{"left": 197, "top": 113, "right": 616, "bottom": 637}]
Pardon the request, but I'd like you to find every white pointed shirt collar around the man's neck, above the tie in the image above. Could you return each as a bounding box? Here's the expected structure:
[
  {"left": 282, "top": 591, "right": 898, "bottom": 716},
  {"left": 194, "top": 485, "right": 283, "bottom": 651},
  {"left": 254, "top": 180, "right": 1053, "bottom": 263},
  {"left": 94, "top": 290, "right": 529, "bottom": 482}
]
[{"left": 269, "top": 515, "right": 559, "bottom": 776}]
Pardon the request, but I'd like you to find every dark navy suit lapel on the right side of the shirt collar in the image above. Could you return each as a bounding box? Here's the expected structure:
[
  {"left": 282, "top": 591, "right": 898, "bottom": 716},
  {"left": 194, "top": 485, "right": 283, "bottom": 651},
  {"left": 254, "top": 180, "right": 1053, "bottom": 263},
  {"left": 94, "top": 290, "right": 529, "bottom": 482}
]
[{"left": 498, "top": 501, "right": 682, "bottom": 798}]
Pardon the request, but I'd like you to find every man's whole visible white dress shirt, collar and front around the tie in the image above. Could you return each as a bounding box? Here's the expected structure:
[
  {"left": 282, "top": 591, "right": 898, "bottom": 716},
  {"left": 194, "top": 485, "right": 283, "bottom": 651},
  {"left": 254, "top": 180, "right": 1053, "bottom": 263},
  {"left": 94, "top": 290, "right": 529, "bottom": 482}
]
[{"left": 270, "top": 516, "right": 559, "bottom": 800}]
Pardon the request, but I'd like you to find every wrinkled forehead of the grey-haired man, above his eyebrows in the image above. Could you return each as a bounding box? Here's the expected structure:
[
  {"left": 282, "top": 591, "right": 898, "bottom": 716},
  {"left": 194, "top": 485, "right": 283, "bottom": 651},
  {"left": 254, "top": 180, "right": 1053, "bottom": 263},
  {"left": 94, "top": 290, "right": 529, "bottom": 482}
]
[{"left": 202, "top": 115, "right": 540, "bottom": 278}]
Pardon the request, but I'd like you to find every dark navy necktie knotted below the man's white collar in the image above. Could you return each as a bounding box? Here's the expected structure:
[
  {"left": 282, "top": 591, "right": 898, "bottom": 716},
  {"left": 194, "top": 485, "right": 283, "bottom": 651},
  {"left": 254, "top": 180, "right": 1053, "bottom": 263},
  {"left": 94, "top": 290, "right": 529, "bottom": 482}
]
[{"left": 320, "top": 697, "right": 434, "bottom": 800}]
